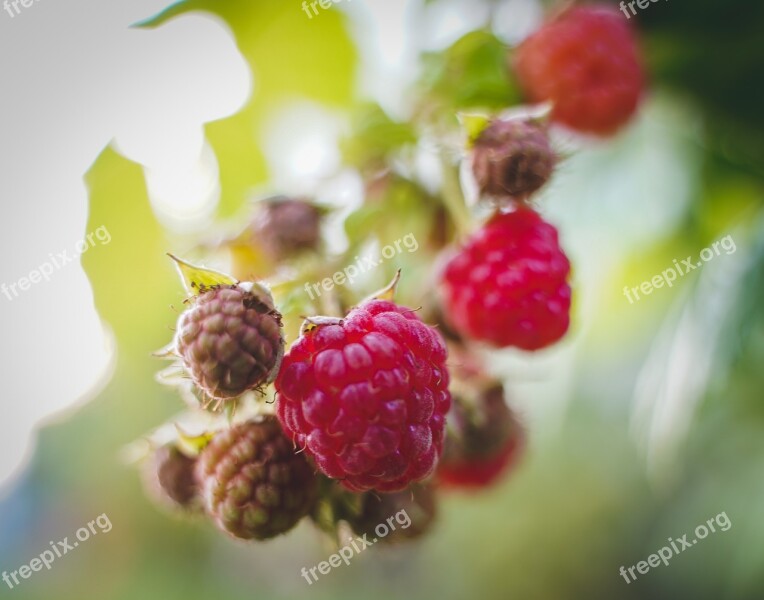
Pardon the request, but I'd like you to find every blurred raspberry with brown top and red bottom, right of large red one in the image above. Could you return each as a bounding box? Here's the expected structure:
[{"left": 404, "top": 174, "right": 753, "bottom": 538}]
[{"left": 438, "top": 384, "right": 524, "bottom": 489}]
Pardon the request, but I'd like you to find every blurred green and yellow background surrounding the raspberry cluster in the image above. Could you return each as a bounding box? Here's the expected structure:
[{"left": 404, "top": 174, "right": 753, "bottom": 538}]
[{"left": 0, "top": 0, "right": 764, "bottom": 600}]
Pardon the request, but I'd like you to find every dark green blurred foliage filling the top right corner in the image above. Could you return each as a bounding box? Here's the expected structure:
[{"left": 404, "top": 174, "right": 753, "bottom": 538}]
[{"left": 639, "top": 0, "right": 764, "bottom": 177}]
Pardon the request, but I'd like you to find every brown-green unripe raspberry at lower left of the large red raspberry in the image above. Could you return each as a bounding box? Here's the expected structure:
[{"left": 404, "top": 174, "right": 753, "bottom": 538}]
[{"left": 196, "top": 417, "right": 318, "bottom": 540}]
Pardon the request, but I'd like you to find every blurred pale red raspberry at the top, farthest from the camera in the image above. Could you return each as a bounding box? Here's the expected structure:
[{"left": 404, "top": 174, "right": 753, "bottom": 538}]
[{"left": 515, "top": 5, "right": 645, "bottom": 135}]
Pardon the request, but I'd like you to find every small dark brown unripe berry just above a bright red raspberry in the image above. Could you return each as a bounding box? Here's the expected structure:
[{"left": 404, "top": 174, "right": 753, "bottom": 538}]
[{"left": 472, "top": 119, "right": 556, "bottom": 200}]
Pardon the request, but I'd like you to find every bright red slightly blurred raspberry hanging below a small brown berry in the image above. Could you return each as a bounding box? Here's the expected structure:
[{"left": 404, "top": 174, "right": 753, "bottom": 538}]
[{"left": 442, "top": 207, "right": 571, "bottom": 350}]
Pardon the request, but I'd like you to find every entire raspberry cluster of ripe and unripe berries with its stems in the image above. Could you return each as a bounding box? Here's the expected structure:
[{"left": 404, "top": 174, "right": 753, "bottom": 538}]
[{"left": 139, "top": 5, "right": 644, "bottom": 542}]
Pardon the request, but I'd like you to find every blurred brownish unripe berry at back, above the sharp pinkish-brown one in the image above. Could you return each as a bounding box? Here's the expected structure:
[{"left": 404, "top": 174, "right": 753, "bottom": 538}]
[{"left": 252, "top": 196, "right": 322, "bottom": 260}]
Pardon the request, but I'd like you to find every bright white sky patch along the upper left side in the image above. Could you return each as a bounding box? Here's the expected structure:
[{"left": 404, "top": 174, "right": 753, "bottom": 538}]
[{"left": 0, "top": 0, "right": 252, "bottom": 493}]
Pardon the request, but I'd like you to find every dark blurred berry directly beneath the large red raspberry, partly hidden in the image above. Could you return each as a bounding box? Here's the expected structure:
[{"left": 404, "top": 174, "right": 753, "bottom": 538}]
[{"left": 345, "top": 484, "right": 437, "bottom": 543}]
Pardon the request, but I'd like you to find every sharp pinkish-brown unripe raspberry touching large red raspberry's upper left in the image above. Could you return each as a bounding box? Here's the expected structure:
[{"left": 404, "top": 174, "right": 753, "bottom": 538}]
[{"left": 175, "top": 284, "right": 284, "bottom": 401}]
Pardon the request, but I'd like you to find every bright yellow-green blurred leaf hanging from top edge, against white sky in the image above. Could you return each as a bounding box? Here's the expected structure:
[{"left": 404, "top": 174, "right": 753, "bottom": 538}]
[{"left": 141, "top": 0, "right": 357, "bottom": 216}]
